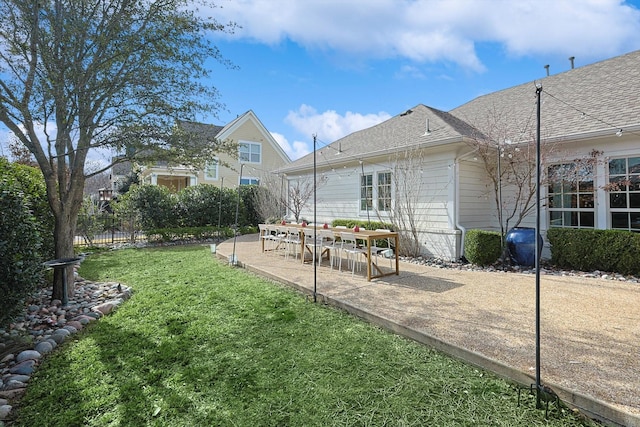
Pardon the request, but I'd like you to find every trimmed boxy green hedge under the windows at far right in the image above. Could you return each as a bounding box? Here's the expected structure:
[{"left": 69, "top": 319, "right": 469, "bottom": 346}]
[{"left": 547, "top": 228, "right": 640, "bottom": 275}]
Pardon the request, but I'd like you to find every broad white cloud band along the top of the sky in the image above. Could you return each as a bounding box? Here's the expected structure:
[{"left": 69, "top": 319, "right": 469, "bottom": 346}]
[{"left": 212, "top": 0, "right": 640, "bottom": 71}]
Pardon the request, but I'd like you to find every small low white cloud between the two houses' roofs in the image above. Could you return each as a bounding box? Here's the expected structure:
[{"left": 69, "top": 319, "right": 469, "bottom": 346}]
[{"left": 285, "top": 104, "right": 391, "bottom": 143}]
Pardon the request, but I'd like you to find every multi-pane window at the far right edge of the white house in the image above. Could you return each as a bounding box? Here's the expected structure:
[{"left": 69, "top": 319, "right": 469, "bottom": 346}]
[{"left": 607, "top": 157, "right": 640, "bottom": 232}]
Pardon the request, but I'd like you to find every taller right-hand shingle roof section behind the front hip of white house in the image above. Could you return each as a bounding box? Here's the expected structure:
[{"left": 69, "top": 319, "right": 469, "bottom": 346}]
[{"left": 450, "top": 51, "right": 640, "bottom": 142}]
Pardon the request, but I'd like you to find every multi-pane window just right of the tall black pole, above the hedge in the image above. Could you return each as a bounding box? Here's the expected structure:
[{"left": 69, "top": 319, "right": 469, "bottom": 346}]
[{"left": 548, "top": 163, "right": 595, "bottom": 228}]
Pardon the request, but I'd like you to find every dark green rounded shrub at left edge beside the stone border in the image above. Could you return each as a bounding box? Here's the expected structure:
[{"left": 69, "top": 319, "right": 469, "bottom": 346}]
[{"left": 0, "top": 175, "right": 43, "bottom": 325}]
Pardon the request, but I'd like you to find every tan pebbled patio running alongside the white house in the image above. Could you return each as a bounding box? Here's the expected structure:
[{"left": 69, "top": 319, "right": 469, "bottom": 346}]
[{"left": 217, "top": 235, "right": 640, "bottom": 426}]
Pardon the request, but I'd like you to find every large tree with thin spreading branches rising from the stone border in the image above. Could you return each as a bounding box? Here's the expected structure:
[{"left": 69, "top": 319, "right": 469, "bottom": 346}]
[{"left": 0, "top": 0, "right": 233, "bottom": 298}]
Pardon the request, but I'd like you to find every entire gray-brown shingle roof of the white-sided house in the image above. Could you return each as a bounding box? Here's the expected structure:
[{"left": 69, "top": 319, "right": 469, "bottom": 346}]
[{"left": 281, "top": 51, "right": 640, "bottom": 172}]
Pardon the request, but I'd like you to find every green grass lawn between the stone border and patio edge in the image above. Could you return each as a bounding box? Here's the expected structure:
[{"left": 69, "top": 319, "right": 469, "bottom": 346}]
[{"left": 15, "top": 245, "right": 586, "bottom": 427}]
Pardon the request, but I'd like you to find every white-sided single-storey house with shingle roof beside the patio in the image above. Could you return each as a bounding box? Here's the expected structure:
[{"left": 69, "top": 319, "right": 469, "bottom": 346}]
[{"left": 278, "top": 51, "right": 640, "bottom": 259}]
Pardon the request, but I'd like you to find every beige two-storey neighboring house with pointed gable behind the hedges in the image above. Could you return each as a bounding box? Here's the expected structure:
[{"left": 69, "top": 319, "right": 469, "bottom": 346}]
[{"left": 141, "top": 110, "right": 291, "bottom": 191}]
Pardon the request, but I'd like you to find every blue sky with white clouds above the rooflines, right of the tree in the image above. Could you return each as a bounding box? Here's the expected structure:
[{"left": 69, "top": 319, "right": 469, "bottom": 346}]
[{"left": 201, "top": 0, "right": 640, "bottom": 159}]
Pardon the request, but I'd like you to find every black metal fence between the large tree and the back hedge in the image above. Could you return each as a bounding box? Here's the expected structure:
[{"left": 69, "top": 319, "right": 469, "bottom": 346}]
[{"left": 73, "top": 212, "right": 145, "bottom": 247}]
